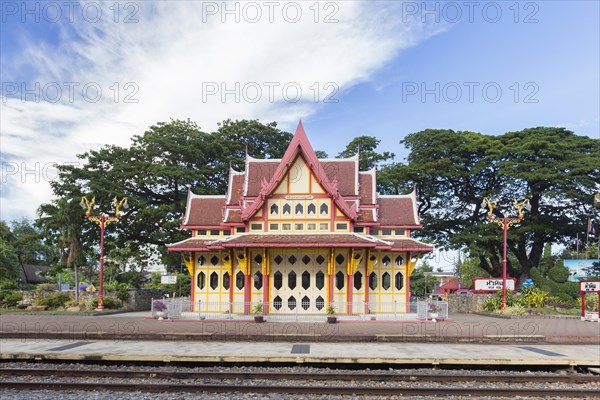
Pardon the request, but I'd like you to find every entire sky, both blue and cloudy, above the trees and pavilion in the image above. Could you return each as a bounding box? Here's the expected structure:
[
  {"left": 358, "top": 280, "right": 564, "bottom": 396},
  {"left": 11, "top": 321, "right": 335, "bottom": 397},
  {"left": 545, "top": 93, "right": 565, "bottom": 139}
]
[{"left": 0, "top": 1, "right": 600, "bottom": 268}]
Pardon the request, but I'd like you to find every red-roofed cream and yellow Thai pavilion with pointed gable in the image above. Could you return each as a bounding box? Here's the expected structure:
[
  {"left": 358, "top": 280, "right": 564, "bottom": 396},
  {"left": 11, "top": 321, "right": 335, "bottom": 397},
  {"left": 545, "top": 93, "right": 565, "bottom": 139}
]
[{"left": 168, "top": 122, "right": 433, "bottom": 314}]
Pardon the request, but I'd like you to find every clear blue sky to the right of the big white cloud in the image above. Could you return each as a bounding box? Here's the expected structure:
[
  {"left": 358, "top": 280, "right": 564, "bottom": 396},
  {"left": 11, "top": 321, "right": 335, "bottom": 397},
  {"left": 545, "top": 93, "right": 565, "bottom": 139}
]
[{"left": 307, "top": 1, "right": 600, "bottom": 157}]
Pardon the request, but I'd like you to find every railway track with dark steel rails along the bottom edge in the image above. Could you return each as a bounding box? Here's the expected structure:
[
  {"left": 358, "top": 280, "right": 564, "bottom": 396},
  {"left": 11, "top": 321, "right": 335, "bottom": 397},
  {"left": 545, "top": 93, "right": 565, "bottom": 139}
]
[{"left": 0, "top": 368, "right": 600, "bottom": 398}]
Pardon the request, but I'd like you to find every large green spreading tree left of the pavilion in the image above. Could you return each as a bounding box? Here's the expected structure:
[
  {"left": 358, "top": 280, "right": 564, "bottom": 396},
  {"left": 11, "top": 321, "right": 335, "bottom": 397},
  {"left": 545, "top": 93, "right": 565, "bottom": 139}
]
[{"left": 43, "top": 120, "right": 292, "bottom": 269}]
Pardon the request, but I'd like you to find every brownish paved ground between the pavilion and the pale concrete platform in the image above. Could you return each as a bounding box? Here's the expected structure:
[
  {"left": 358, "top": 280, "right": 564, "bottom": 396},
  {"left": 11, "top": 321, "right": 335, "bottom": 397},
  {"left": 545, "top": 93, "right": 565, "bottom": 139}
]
[{"left": 0, "top": 312, "right": 600, "bottom": 345}]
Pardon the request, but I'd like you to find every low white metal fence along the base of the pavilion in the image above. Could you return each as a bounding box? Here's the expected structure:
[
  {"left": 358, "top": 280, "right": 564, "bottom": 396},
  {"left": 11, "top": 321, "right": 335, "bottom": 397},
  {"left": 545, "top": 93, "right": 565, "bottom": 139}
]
[{"left": 152, "top": 297, "right": 448, "bottom": 322}]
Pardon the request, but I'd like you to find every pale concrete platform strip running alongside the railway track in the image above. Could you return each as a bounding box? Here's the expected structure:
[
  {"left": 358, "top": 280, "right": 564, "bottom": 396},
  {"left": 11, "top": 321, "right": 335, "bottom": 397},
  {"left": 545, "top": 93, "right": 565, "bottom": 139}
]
[{"left": 0, "top": 339, "right": 600, "bottom": 367}]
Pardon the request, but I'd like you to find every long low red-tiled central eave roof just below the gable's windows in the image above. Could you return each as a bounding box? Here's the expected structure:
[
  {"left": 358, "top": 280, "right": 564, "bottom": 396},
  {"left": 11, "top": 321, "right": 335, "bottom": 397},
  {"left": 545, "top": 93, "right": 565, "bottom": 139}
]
[{"left": 214, "top": 233, "right": 386, "bottom": 248}]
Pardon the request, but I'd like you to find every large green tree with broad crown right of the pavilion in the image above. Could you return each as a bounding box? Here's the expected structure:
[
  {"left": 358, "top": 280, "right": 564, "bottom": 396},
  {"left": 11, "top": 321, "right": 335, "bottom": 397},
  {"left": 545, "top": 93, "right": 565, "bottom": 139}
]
[{"left": 396, "top": 127, "right": 600, "bottom": 279}]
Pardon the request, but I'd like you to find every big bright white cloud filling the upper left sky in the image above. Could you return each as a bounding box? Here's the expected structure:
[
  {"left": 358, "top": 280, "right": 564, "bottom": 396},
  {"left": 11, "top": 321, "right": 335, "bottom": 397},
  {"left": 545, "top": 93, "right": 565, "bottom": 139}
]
[{"left": 0, "top": 2, "right": 443, "bottom": 219}]
